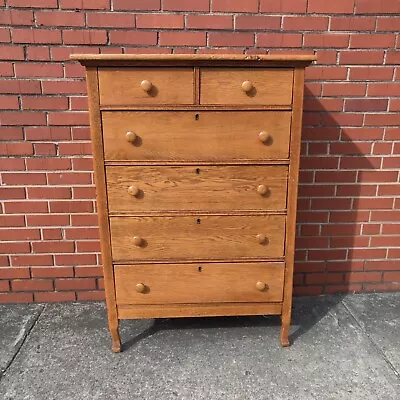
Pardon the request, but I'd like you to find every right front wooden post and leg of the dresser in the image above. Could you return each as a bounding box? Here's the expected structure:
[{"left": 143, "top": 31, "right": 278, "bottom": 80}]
[{"left": 281, "top": 68, "right": 304, "bottom": 346}]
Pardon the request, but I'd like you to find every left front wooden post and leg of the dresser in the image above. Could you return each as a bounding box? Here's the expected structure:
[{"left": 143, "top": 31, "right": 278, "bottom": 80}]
[{"left": 86, "top": 68, "right": 121, "bottom": 353}]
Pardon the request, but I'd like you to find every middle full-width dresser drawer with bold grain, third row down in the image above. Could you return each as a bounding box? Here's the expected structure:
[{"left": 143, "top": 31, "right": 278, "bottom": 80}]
[{"left": 106, "top": 165, "right": 288, "bottom": 213}]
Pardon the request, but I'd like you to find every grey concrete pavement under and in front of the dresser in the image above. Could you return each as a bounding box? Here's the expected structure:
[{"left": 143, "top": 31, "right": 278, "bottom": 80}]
[{"left": 0, "top": 293, "right": 400, "bottom": 400}]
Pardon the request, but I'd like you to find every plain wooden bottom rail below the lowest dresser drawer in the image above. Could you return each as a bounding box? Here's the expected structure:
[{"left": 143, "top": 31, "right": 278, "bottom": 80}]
[{"left": 118, "top": 303, "right": 282, "bottom": 319}]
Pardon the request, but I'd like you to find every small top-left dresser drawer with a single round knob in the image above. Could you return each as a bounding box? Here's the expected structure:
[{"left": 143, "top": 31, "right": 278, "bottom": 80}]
[{"left": 99, "top": 68, "right": 194, "bottom": 106}]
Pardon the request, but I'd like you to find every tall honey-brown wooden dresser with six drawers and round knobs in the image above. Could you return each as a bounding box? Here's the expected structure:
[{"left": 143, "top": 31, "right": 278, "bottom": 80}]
[{"left": 72, "top": 54, "right": 315, "bottom": 352}]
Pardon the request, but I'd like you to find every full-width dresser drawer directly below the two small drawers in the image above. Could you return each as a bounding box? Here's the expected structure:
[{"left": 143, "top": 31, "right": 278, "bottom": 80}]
[{"left": 102, "top": 111, "right": 291, "bottom": 161}]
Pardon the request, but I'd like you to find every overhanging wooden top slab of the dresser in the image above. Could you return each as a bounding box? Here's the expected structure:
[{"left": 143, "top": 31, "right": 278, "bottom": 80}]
[{"left": 70, "top": 54, "right": 317, "bottom": 66}]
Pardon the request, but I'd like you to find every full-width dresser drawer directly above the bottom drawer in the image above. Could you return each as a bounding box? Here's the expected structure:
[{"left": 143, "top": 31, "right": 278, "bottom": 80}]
[{"left": 110, "top": 215, "right": 285, "bottom": 261}]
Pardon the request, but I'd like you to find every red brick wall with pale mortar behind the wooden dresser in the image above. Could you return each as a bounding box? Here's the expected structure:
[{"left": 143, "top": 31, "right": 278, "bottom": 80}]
[{"left": 0, "top": 0, "right": 400, "bottom": 302}]
